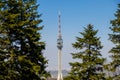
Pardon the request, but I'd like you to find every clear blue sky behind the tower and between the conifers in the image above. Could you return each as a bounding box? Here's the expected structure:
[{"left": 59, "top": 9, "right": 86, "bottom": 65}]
[{"left": 38, "top": 0, "right": 120, "bottom": 70}]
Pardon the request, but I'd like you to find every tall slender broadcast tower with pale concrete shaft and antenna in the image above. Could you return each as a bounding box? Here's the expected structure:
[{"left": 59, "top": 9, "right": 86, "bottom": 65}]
[{"left": 57, "top": 12, "right": 63, "bottom": 80}]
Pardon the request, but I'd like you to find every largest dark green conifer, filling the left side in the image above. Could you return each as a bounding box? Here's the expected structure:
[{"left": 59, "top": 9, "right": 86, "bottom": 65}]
[{"left": 0, "top": 0, "right": 49, "bottom": 80}]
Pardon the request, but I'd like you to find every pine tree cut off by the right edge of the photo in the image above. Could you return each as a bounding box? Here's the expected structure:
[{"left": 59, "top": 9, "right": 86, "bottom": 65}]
[{"left": 109, "top": 4, "right": 120, "bottom": 80}]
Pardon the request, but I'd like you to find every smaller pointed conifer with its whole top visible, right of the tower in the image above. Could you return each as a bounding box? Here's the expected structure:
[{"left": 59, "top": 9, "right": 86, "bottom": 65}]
[{"left": 66, "top": 24, "right": 105, "bottom": 80}]
